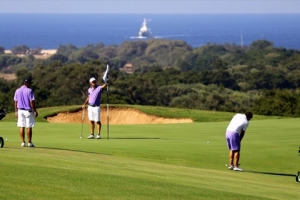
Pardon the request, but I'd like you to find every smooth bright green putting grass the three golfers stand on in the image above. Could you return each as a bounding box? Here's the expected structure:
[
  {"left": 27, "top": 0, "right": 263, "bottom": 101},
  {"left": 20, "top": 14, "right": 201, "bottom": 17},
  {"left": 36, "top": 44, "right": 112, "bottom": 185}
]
[{"left": 0, "top": 119, "right": 300, "bottom": 200}]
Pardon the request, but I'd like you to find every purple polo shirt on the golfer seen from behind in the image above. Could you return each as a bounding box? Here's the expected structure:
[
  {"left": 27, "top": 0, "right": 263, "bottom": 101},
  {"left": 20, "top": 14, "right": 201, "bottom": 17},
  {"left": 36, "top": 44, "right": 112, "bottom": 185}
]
[{"left": 14, "top": 85, "right": 34, "bottom": 110}]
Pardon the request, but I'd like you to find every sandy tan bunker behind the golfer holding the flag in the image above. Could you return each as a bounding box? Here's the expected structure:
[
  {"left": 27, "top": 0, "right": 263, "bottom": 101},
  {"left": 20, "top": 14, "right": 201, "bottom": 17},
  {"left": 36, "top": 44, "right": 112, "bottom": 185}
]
[{"left": 47, "top": 107, "right": 193, "bottom": 124}]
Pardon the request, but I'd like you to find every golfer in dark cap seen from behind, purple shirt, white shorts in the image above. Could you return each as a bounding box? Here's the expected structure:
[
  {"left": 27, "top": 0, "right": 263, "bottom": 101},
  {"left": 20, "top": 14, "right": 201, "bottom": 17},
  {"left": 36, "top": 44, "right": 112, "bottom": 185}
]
[{"left": 14, "top": 78, "right": 38, "bottom": 147}]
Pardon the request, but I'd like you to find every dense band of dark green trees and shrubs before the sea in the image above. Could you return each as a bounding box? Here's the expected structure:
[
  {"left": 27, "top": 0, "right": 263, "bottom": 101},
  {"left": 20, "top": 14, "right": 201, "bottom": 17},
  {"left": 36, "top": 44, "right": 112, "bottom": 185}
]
[{"left": 0, "top": 39, "right": 300, "bottom": 117}]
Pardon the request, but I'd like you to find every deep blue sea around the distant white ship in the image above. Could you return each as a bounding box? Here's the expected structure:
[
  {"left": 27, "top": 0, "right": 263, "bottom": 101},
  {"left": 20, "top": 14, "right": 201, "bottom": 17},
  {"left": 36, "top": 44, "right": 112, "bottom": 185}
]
[{"left": 0, "top": 13, "right": 300, "bottom": 50}]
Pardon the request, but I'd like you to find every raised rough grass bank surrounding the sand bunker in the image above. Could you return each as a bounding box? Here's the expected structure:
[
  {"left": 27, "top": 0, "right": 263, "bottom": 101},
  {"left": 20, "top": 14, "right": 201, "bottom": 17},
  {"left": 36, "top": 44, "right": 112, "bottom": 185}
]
[{"left": 3, "top": 104, "right": 284, "bottom": 122}]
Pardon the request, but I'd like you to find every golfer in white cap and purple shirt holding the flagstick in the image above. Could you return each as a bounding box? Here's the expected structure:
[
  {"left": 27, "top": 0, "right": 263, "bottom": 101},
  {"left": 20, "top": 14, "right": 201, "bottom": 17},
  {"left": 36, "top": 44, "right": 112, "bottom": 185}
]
[{"left": 82, "top": 78, "right": 106, "bottom": 139}]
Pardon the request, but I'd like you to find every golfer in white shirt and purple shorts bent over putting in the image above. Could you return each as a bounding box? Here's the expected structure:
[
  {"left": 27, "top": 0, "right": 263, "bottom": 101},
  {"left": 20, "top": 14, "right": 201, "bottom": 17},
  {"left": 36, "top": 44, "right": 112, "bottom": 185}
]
[{"left": 226, "top": 112, "right": 253, "bottom": 172}]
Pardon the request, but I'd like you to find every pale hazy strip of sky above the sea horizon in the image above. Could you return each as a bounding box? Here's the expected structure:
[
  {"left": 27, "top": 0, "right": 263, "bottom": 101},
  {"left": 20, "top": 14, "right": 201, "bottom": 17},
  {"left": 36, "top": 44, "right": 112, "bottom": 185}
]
[{"left": 0, "top": 0, "right": 300, "bottom": 14}]
